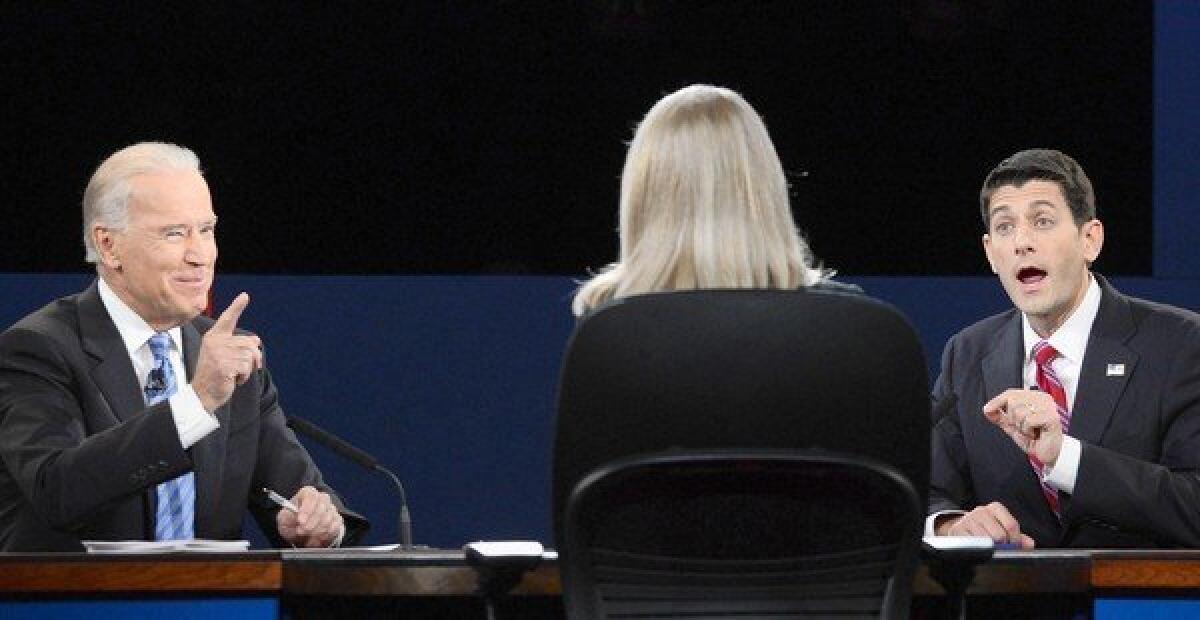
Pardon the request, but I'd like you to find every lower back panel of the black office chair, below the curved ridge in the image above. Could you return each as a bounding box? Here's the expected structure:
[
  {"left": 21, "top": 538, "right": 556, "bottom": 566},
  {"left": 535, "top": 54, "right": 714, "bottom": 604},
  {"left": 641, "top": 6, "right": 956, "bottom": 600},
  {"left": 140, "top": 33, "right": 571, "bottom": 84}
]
[{"left": 560, "top": 451, "right": 923, "bottom": 619}]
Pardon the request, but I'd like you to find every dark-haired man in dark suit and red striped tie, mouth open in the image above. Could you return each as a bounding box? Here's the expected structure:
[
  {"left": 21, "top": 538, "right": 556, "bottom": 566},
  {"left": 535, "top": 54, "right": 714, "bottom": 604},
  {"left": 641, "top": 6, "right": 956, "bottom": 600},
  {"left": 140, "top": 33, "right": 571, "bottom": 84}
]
[{"left": 926, "top": 149, "right": 1200, "bottom": 548}]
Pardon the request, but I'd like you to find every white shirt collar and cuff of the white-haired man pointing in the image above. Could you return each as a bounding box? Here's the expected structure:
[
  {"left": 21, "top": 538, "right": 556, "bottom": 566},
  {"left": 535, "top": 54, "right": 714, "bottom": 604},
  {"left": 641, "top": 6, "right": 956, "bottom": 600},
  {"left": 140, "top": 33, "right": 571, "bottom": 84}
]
[{"left": 96, "top": 278, "right": 221, "bottom": 450}]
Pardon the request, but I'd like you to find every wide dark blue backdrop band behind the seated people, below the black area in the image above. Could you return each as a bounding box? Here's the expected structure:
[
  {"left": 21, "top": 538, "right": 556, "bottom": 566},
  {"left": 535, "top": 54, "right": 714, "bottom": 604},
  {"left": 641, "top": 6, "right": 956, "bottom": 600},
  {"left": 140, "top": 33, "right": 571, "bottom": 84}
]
[{"left": 0, "top": 275, "right": 1200, "bottom": 547}]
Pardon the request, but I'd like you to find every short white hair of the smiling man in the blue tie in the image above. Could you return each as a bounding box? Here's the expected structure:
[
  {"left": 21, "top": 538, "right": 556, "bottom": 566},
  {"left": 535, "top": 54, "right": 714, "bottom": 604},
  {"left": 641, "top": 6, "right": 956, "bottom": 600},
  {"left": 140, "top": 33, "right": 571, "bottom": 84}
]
[{"left": 83, "top": 142, "right": 200, "bottom": 263}]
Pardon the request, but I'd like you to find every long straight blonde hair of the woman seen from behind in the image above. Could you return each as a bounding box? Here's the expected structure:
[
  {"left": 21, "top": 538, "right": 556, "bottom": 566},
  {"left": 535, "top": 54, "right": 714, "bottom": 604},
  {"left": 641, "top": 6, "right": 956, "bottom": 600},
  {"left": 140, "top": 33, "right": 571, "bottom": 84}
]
[{"left": 571, "top": 84, "right": 832, "bottom": 315}]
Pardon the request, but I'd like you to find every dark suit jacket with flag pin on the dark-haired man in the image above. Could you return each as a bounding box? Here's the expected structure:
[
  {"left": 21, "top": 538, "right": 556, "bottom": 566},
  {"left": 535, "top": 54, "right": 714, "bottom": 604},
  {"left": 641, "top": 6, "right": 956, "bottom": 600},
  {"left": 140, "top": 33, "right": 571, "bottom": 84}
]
[{"left": 929, "top": 276, "right": 1200, "bottom": 547}]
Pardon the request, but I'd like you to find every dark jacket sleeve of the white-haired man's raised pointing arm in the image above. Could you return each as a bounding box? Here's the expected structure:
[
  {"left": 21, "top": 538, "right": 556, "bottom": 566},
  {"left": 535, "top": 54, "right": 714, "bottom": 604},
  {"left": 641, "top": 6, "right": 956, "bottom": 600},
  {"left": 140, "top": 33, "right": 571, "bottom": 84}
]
[{"left": 0, "top": 327, "right": 191, "bottom": 531}]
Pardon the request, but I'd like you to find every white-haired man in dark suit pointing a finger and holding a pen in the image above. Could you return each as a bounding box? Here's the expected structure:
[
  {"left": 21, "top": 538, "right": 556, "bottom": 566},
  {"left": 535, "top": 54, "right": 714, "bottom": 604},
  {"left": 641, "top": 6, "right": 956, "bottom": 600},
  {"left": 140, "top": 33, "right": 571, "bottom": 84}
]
[{"left": 0, "top": 143, "right": 366, "bottom": 550}]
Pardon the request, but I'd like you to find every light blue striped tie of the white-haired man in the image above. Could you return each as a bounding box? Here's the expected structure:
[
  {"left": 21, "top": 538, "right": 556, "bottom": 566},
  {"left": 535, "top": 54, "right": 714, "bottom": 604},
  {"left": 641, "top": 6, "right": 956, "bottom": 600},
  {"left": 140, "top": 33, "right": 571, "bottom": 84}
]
[{"left": 145, "top": 331, "right": 196, "bottom": 541}]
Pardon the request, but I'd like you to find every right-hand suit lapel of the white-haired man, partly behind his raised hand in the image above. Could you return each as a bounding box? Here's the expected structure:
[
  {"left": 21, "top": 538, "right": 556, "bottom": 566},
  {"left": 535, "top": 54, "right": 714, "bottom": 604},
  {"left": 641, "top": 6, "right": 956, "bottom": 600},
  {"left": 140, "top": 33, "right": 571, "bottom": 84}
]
[{"left": 181, "top": 323, "right": 229, "bottom": 538}]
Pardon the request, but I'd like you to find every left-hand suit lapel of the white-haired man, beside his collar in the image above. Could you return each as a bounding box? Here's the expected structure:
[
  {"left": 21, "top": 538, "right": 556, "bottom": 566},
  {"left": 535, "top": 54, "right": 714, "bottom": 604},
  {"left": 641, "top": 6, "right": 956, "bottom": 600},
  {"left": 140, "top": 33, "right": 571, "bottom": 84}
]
[{"left": 79, "top": 282, "right": 146, "bottom": 422}]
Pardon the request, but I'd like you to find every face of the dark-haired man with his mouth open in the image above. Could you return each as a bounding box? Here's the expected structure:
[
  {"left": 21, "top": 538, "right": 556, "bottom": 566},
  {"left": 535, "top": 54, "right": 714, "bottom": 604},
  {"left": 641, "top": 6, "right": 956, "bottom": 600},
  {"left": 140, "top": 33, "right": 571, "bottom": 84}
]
[{"left": 983, "top": 181, "right": 1104, "bottom": 337}]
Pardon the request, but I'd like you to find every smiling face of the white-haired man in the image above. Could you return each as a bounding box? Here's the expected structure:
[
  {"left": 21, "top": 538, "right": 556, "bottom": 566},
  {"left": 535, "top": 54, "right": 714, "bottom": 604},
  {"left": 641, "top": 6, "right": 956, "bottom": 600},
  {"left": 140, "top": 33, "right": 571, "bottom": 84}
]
[{"left": 92, "top": 170, "right": 217, "bottom": 331}]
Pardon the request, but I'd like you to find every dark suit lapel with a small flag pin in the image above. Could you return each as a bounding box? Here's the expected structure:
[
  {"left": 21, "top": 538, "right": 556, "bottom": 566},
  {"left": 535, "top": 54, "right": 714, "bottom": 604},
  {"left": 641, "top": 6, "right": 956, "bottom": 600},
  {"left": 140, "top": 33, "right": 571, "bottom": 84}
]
[{"left": 1070, "top": 276, "right": 1139, "bottom": 444}]
